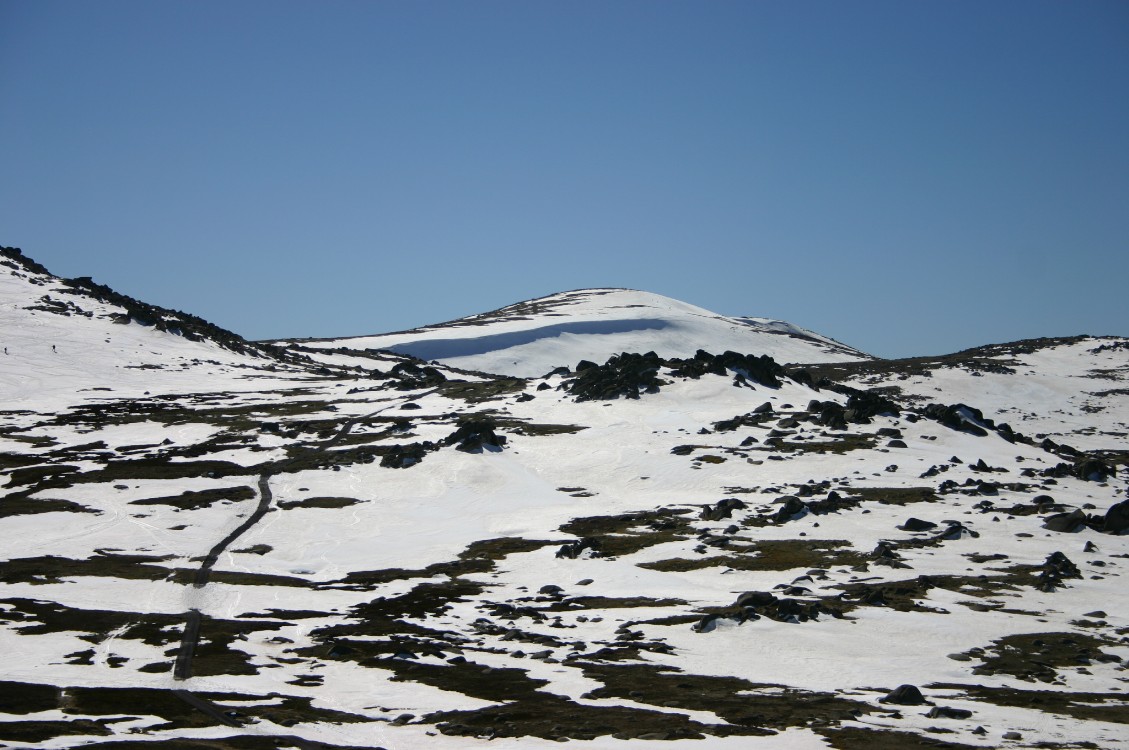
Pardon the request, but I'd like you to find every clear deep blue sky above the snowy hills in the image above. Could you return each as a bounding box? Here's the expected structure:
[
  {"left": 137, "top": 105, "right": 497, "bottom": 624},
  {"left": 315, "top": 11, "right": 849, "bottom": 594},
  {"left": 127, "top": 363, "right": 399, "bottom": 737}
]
[{"left": 0, "top": 0, "right": 1129, "bottom": 356}]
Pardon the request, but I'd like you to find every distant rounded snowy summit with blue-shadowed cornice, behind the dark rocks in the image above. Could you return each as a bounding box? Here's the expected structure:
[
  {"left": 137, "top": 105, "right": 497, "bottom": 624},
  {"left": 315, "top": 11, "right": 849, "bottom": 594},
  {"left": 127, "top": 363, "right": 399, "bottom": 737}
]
[{"left": 279, "top": 289, "right": 869, "bottom": 377}]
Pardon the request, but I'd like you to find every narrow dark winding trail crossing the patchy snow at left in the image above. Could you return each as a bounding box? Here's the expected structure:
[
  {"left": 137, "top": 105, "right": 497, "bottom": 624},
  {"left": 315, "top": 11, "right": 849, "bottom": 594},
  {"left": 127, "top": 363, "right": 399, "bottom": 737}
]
[{"left": 173, "top": 389, "right": 439, "bottom": 747}]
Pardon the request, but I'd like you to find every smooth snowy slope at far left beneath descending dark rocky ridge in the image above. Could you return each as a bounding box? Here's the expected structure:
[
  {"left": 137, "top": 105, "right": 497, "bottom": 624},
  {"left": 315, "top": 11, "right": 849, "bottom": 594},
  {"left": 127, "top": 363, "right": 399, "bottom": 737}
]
[{"left": 0, "top": 247, "right": 329, "bottom": 409}]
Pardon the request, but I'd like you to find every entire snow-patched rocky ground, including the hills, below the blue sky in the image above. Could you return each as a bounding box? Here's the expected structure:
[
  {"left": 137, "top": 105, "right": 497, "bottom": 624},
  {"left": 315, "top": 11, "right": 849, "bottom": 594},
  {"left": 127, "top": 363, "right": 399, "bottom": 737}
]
[{"left": 0, "top": 251, "right": 1129, "bottom": 750}]
